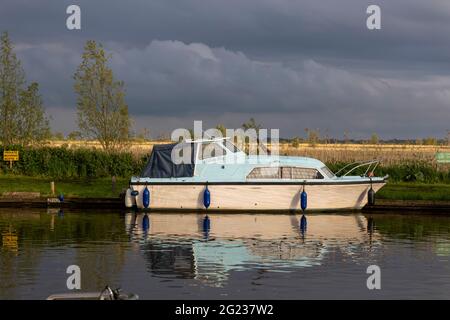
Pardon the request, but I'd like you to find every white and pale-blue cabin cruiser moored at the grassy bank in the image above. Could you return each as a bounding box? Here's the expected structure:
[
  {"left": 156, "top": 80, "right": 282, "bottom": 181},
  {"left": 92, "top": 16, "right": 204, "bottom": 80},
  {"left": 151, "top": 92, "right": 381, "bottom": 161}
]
[{"left": 125, "top": 138, "right": 387, "bottom": 211}]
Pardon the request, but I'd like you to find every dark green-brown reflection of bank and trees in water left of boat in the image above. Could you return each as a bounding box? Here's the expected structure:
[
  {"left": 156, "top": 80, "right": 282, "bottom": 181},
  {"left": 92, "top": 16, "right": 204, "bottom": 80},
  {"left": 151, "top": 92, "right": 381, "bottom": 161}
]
[{"left": 0, "top": 210, "right": 128, "bottom": 299}]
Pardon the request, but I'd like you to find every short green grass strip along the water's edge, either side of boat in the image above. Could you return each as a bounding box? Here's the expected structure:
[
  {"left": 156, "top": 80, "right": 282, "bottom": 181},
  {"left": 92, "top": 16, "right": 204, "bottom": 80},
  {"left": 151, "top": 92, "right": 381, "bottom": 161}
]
[{"left": 0, "top": 175, "right": 450, "bottom": 201}]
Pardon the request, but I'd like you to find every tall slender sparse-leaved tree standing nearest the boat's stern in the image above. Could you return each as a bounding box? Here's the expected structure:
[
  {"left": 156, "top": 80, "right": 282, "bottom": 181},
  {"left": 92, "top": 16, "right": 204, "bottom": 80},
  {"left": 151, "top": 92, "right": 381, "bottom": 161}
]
[{"left": 74, "top": 41, "right": 131, "bottom": 151}]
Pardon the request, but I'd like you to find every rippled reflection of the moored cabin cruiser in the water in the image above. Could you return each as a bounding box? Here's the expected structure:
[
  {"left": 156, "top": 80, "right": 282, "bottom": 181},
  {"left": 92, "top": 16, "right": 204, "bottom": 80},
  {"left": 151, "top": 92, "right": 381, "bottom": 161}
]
[{"left": 125, "top": 212, "right": 380, "bottom": 286}]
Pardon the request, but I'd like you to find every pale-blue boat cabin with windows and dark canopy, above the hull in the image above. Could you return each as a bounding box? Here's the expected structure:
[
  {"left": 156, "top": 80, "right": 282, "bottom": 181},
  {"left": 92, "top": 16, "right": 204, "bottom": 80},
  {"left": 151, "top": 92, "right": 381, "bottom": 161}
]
[{"left": 139, "top": 138, "right": 335, "bottom": 182}]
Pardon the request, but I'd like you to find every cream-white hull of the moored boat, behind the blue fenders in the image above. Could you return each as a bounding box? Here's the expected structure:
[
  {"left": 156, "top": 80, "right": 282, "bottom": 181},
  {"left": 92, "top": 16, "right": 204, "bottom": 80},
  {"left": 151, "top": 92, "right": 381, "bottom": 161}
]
[{"left": 128, "top": 182, "right": 385, "bottom": 211}]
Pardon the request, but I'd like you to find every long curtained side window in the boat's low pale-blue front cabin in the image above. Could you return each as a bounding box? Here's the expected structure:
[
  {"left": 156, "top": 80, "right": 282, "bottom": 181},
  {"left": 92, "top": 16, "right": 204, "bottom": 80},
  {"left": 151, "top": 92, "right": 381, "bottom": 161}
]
[{"left": 247, "top": 167, "right": 323, "bottom": 180}]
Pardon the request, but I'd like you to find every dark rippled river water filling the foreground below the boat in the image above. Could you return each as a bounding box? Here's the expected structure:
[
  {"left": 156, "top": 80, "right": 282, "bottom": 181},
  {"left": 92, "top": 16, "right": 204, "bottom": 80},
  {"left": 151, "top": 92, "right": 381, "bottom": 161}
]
[{"left": 0, "top": 209, "right": 450, "bottom": 299}]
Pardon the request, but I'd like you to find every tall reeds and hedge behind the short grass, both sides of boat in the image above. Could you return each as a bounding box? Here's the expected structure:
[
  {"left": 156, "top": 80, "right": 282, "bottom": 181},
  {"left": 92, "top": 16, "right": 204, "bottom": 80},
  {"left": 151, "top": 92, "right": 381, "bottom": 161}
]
[{"left": 0, "top": 145, "right": 450, "bottom": 183}]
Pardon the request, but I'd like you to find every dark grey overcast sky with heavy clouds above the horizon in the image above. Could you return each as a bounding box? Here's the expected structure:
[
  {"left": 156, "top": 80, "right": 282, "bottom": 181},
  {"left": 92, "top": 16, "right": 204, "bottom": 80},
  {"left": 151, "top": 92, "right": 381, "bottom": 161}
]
[{"left": 0, "top": 0, "right": 450, "bottom": 138}]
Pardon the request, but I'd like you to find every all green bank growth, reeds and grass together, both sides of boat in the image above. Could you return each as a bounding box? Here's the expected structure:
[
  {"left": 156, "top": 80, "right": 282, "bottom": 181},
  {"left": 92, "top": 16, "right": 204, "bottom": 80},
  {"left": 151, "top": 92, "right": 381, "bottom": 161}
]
[{"left": 0, "top": 142, "right": 450, "bottom": 201}]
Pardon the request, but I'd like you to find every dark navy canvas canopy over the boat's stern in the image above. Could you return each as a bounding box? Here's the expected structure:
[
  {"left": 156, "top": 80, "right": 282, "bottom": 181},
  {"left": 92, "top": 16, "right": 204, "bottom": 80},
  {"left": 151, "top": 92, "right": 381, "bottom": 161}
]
[{"left": 141, "top": 143, "right": 195, "bottom": 178}]
